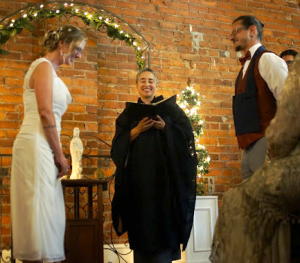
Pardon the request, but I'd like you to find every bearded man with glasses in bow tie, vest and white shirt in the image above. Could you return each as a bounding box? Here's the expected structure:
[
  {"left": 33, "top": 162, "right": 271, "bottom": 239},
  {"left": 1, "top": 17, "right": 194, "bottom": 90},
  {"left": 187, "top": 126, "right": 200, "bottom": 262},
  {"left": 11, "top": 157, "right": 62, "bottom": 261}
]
[{"left": 230, "top": 16, "right": 288, "bottom": 180}]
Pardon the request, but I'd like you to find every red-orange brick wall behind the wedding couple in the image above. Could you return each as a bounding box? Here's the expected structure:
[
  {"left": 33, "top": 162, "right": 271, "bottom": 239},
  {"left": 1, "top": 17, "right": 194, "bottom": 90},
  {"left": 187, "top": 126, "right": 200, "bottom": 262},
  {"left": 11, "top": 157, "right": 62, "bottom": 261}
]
[{"left": 0, "top": 0, "right": 300, "bottom": 246}]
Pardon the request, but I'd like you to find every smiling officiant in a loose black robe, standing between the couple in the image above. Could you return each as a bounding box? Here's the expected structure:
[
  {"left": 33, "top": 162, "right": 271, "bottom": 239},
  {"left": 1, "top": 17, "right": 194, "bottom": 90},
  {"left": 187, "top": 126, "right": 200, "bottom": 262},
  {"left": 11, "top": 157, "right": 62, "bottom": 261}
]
[{"left": 111, "top": 68, "right": 197, "bottom": 263}]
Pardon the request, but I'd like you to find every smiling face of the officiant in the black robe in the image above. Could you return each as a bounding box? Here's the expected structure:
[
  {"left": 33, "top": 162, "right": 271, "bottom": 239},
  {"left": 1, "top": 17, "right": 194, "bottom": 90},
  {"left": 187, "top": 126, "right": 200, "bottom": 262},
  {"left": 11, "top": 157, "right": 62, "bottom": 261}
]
[{"left": 136, "top": 71, "right": 158, "bottom": 103}]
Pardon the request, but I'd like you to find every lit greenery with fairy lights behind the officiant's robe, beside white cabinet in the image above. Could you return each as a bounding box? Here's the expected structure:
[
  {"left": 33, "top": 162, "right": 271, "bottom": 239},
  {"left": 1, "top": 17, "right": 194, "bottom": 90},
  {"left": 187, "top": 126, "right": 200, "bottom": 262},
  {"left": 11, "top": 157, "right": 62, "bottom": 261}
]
[{"left": 177, "top": 80, "right": 211, "bottom": 189}]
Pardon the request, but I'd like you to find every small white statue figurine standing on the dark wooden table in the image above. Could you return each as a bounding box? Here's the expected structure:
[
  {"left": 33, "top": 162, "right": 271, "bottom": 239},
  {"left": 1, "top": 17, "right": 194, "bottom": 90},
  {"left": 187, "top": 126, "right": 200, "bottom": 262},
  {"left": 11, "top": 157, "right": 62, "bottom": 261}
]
[{"left": 70, "top": 127, "right": 83, "bottom": 179}]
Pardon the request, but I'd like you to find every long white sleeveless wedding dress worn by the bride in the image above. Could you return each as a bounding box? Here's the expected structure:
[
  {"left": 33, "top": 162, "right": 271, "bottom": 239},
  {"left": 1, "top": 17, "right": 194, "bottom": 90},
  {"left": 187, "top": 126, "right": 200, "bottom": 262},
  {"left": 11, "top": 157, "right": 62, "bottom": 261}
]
[{"left": 11, "top": 58, "right": 71, "bottom": 262}]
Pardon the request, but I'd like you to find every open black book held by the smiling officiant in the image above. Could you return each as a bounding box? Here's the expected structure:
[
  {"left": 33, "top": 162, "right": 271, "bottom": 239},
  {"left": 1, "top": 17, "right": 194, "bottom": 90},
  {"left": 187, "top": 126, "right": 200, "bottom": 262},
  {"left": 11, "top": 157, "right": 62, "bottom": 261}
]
[{"left": 126, "top": 95, "right": 177, "bottom": 122}]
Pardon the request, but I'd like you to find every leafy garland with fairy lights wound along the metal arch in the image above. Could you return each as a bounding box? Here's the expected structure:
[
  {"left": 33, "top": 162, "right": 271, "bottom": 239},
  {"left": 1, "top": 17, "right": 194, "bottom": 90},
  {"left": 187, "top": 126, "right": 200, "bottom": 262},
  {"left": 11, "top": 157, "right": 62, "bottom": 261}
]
[{"left": 0, "top": 2, "right": 147, "bottom": 69}]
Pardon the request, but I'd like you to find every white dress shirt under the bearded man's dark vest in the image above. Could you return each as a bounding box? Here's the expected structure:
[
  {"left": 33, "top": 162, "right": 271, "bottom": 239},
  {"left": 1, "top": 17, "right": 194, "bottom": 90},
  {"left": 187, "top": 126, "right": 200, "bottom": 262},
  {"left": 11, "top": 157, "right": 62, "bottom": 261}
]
[{"left": 243, "top": 43, "right": 288, "bottom": 99}]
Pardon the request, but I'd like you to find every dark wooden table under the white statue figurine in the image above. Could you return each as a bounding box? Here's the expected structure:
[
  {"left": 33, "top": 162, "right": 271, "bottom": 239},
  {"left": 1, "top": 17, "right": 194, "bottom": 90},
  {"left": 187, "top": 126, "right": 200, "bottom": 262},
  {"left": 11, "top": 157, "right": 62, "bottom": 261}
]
[{"left": 62, "top": 179, "right": 107, "bottom": 263}]
